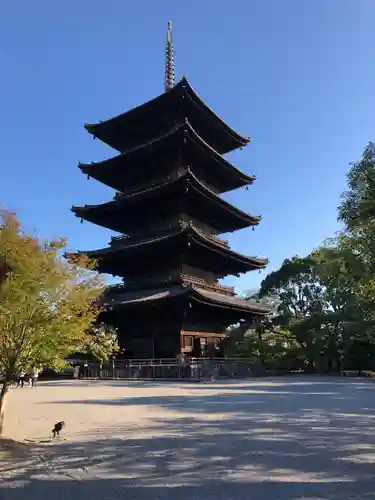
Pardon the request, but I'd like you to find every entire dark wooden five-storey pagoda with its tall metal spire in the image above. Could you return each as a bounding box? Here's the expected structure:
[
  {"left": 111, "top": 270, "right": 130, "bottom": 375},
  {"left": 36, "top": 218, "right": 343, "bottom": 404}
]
[{"left": 72, "top": 23, "right": 268, "bottom": 358}]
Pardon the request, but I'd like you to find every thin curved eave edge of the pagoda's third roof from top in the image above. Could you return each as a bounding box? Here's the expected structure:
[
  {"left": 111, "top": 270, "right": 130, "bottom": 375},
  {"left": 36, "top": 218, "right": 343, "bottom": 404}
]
[{"left": 71, "top": 170, "right": 262, "bottom": 227}]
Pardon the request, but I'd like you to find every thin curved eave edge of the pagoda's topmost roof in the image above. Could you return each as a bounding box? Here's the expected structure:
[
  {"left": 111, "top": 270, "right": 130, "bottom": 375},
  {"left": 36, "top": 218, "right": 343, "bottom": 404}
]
[{"left": 84, "top": 77, "right": 250, "bottom": 152}]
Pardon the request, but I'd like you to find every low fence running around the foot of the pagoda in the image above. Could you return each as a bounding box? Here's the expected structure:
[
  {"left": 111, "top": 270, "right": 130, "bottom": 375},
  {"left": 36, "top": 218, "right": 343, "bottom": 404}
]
[{"left": 69, "top": 358, "right": 264, "bottom": 381}]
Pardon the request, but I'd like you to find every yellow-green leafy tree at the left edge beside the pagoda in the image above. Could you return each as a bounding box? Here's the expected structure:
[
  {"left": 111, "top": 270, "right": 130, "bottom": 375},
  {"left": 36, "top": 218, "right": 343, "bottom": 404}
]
[{"left": 0, "top": 211, "right": 105, "bottom": 434}]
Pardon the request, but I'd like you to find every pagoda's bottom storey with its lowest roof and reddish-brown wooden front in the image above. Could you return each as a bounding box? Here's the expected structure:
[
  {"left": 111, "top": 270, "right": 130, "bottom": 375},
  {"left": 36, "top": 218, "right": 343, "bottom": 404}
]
[{"left": 99, "top": 287, "right": 268, "bottom": 359}]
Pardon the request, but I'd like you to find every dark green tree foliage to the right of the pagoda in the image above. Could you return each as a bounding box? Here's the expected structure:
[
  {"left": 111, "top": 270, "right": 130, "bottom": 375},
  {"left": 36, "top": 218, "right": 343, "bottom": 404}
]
[{"left": 235, "top": 143, "right": 375, "bottom": 370}]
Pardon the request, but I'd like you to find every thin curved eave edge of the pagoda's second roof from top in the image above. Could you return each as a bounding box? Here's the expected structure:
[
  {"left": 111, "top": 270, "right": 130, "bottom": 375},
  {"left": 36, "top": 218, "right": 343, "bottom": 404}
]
[{"left": 78, "top": 120, "right": 255, "bottom": 192}]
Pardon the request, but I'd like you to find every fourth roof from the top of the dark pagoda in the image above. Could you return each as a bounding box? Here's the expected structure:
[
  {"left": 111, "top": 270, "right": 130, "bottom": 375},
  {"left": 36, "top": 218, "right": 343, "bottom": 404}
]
[{"left": 74, "top": 224, "right": 268, "bottom": 276}]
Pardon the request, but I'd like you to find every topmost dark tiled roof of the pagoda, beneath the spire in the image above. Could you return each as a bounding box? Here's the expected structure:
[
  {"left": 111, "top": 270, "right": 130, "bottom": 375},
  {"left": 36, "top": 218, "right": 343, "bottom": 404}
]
[{"left": 85, "top": 77, "right": 249, "bottom": 153}]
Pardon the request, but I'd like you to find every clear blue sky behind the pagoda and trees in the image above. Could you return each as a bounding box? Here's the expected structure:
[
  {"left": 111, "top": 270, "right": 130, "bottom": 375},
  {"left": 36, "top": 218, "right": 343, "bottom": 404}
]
[{"left": 0, "top": 0, "right": 375, "bottom": 292}]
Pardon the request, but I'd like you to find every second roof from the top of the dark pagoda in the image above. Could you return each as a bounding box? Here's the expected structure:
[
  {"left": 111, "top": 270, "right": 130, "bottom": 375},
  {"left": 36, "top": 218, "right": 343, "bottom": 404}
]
[{"left": 78, "top": 120, "right": 255, "bottom": 193}]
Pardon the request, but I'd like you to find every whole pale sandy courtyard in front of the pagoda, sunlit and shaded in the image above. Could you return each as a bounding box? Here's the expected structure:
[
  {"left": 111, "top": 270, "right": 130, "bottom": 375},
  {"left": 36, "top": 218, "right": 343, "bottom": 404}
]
[{"left": 0, "top": 377, "right": 375, "bottom": 500}]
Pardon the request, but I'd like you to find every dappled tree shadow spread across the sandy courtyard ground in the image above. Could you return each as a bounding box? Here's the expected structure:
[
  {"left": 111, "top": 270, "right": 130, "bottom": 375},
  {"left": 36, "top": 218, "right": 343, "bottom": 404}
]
[{"left": 0, "top": 381, "right": 375, "bottom": 500}]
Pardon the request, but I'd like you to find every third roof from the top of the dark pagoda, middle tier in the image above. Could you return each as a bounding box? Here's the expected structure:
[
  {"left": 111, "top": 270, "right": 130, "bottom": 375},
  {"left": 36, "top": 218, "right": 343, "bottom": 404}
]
[{"left": 71, "top": 169, "right": 261, "bottom": 233}]
